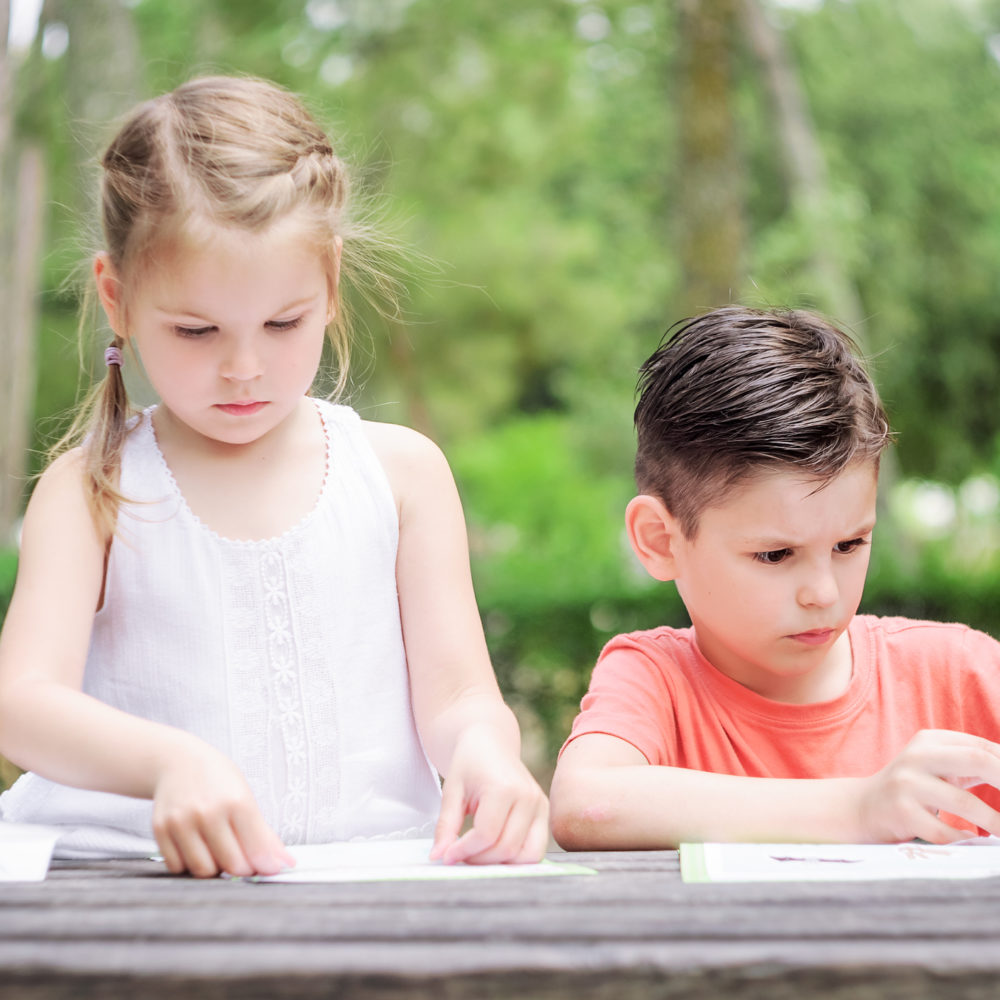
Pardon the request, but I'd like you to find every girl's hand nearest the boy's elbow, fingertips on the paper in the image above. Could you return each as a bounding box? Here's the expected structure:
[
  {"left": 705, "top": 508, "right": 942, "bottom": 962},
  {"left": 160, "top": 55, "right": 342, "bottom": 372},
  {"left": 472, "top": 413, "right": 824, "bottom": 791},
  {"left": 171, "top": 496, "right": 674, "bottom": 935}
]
[{"left": 431, "top": 727, "right": 549, "bottom": 864}]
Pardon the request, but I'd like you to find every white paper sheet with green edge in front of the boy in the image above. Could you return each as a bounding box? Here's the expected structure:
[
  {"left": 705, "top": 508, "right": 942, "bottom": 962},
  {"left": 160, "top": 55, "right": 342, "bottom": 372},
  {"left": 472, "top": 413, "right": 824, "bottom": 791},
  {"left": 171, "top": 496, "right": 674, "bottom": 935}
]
[{"left": 681, "top": 837, "right": 1000, "bottom": 882}]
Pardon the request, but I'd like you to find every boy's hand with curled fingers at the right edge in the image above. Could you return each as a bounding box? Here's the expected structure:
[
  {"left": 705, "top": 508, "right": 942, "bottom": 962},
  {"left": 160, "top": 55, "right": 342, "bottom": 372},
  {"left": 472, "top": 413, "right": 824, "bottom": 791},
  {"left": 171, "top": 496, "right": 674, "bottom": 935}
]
[{"left": 858, "top": 729, "right": 1000, "bottom": 844}]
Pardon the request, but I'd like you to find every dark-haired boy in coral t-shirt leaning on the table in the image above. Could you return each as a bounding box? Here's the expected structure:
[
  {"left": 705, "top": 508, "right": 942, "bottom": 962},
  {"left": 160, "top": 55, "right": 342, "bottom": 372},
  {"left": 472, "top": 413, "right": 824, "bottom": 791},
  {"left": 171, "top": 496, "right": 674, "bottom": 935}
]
[{"left": 551, "top": 307, "right": 1000, "bottom": 850}]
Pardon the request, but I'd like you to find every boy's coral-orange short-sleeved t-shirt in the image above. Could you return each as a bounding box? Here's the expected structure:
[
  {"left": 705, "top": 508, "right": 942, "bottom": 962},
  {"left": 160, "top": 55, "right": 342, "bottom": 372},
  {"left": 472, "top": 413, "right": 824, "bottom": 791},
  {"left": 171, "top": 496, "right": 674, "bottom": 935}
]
[{"left": 566, "top": 615, "right": 1000, "bottom": 820}]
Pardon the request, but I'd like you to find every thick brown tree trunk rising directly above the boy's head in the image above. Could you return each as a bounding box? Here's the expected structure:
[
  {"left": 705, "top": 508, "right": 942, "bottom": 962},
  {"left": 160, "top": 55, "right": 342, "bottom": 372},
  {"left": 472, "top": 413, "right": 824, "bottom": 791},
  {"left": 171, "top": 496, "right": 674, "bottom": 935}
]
[{"left": 672, "top": 0, "right": 744, "bottom": 315}]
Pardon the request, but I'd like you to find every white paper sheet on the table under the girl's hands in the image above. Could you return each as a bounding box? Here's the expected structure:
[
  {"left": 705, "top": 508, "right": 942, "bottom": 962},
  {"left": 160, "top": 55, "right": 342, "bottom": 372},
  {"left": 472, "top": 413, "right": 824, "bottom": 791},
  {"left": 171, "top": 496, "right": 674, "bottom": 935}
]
[{"left": 242, "top": 839, "right": 597, "bottom": 882}]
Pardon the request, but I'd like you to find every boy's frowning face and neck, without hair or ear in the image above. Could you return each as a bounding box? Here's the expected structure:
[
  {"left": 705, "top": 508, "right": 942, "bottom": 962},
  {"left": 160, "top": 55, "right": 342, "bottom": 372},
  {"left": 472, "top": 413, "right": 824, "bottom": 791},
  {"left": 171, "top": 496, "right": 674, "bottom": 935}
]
[{"left": 671, "top": 462, "right": 877, "bottom": 703}]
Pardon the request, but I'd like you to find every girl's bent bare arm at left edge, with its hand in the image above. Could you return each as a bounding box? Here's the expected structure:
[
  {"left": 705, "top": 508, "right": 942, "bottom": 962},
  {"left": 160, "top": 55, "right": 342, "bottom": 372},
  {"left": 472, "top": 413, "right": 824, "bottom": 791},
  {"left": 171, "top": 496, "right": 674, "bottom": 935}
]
[{"left": 0, "top": 452, "right": 291, "bottom": 875}]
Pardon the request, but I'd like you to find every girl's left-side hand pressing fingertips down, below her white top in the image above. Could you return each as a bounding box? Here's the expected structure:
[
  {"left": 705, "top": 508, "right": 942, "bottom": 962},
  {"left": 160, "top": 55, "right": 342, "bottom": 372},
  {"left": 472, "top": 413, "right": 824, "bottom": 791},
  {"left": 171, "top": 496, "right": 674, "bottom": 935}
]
[{"left": 153, "top": 744, "right": 295, "bottom": 878}]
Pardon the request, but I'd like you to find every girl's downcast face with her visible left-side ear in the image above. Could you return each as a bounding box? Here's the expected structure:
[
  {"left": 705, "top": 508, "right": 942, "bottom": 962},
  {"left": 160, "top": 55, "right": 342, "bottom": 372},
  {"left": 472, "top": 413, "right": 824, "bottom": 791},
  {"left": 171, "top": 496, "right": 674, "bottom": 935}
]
[{"left": 95, "top": 220, "right": 333, "bottom": 445}]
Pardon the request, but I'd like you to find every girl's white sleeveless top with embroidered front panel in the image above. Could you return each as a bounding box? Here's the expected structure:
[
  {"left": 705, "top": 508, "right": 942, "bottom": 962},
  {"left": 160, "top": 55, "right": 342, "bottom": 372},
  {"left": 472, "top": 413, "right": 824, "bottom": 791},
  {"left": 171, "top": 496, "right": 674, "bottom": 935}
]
[{"left": 0, "top": 400, "right": 440, "bottom": 857}]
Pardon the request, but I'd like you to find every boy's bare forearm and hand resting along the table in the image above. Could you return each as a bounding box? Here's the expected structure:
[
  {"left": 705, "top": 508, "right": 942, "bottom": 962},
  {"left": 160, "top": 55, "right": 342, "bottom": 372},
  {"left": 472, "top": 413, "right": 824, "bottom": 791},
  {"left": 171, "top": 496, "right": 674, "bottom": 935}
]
[{"left": 551, "top": 730, "right": 1000, "bottom": 850}]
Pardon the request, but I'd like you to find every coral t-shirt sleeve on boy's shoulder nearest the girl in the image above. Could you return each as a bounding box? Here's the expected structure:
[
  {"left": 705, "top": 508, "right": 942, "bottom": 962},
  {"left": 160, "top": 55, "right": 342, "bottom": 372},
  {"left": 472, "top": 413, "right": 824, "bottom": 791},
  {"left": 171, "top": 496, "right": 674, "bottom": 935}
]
[{"left": 560, "top": 636, "right": 677, "bottom": 765}]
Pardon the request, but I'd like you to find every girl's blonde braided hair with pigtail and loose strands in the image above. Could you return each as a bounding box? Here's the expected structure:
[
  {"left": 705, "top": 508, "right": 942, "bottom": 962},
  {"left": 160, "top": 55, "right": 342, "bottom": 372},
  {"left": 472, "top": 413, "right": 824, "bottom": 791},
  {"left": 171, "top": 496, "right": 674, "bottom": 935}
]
[{"left": 55, "top": 77, "right": 368, "bottom": 537}]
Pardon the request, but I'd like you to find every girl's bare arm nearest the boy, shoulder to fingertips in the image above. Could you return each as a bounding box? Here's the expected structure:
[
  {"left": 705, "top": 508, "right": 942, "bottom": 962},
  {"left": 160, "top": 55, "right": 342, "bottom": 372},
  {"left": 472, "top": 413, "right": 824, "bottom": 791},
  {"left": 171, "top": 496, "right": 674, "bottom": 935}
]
[{"left": 365, "top": 423, "right": 548, "bottom": 863}]
